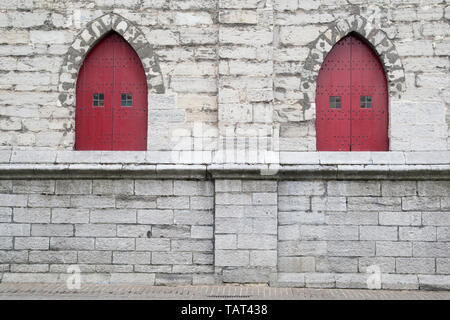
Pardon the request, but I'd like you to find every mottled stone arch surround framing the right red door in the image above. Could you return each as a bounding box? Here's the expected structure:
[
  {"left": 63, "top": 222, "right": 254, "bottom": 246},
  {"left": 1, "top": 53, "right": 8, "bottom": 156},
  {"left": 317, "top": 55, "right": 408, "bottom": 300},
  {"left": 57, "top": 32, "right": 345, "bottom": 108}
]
[{"left": 300, "top": 15, "right": 406, "bottom": 109}]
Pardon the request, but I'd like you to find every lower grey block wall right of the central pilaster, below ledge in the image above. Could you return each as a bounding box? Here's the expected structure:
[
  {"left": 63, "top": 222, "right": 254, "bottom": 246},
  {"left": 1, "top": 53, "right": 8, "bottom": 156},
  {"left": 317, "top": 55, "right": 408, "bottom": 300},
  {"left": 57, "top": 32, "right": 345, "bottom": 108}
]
[{"left": 278, "top": 180, "right": 450, "bottom": 289}]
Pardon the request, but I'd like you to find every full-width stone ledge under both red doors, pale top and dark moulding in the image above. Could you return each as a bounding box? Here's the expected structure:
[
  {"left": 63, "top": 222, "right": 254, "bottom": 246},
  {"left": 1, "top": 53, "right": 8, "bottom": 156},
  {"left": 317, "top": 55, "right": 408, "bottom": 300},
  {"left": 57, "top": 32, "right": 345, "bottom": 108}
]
[{"left": 0, "top": 149, "right": 450, "bottom": 180}]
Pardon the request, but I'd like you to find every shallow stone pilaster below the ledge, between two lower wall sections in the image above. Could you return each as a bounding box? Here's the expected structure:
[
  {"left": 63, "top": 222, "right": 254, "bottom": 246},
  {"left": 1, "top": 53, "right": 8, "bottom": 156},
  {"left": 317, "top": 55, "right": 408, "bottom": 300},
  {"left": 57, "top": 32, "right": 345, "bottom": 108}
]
[{"left": 214, "top": 180, "right": 277, "bottom": 283}]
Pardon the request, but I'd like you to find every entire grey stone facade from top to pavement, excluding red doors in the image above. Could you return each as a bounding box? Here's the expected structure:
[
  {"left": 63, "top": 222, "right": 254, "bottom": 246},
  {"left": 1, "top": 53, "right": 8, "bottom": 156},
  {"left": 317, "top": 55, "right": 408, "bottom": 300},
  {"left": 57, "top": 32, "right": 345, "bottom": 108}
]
[{"left": 0, "top": 0, "right": 450, "bottom": 289}]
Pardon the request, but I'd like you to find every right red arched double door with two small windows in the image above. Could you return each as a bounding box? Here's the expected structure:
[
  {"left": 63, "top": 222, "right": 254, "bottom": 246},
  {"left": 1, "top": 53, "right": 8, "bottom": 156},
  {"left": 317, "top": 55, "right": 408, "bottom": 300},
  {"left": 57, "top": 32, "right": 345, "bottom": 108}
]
[{"left": 316, "top": 35, "right": 389, "bottom": 151}]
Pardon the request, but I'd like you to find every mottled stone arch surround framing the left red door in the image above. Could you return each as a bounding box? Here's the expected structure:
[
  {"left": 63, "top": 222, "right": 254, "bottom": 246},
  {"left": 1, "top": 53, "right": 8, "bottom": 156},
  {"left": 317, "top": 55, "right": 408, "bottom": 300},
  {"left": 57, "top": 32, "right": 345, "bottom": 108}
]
[{"left": 58, "top": 13, "right": 165, "bottom": 117}]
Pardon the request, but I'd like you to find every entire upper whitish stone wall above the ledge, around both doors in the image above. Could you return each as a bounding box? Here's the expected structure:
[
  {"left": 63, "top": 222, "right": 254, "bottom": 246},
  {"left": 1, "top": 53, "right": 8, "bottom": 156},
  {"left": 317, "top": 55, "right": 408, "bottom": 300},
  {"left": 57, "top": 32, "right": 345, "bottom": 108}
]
[{"left": 0, "top": 0, "right": 450, "bottom": 152}]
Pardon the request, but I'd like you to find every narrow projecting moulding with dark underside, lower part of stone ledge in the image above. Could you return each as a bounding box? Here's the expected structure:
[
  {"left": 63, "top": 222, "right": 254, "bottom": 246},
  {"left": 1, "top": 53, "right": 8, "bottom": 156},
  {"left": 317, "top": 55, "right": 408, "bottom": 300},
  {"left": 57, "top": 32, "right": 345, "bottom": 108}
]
[{"left": 0, "top": 163, "right": 450, "bottom": 180}]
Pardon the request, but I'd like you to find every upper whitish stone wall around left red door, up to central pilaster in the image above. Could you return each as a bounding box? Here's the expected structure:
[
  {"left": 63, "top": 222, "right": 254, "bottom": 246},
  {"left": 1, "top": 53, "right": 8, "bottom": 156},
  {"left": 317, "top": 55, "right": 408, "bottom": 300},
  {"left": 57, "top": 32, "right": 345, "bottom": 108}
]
[{"left": 0, "top": 0, "right": 218, "bottom": 150}]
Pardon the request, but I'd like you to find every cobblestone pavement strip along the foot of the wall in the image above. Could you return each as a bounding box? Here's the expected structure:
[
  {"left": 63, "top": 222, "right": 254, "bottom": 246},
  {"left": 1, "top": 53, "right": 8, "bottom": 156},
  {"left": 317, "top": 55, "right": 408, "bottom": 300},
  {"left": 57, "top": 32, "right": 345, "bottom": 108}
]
[{"left": 0, "top": 283, "right": 450, "bottom": 300}]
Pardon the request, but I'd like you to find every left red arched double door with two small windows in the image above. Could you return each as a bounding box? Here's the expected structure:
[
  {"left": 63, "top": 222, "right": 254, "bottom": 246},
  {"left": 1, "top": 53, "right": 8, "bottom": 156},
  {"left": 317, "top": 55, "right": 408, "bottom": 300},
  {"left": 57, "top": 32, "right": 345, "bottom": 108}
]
[{"left": 75, "top": 32, "right": 147, "bottom": 150}]
